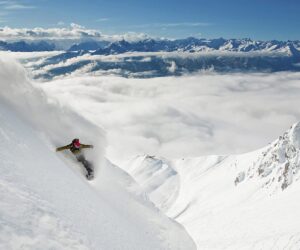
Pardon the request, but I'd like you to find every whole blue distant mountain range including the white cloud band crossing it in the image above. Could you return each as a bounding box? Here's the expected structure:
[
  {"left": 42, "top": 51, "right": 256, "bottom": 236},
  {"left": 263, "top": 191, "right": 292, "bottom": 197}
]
[{"left": 0, "top": 38, "right": 300, "bottom": 79}]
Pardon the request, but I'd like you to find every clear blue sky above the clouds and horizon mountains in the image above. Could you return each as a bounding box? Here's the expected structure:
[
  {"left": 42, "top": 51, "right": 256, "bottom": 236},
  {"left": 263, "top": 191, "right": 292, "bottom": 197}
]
[{"left": 0, "top": 0, "right": 300, "bottom": 40}]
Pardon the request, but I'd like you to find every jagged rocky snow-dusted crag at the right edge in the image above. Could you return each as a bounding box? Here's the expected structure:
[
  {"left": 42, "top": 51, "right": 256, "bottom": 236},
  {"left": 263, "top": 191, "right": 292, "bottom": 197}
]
[{"left": 236, "top": 123, "right": 300, "bottom": 193}]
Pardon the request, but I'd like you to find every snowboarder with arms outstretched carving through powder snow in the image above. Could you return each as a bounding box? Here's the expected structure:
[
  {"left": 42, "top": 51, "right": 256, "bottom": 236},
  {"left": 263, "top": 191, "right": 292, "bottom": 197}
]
[{"left": 56, "top": 138, "right": 94, "bottom": 180}]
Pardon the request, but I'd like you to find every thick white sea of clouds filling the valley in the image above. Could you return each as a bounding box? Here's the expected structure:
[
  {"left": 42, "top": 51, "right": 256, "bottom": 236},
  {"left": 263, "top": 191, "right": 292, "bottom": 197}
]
[{"left": 38, "top": 72, "right": 300, "bottom": 164}]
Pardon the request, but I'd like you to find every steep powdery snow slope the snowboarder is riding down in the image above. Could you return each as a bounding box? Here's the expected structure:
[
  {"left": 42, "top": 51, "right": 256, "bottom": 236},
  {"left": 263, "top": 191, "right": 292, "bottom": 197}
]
[{"left": 0, "top": 59, "right": 195, "bottom": 250}]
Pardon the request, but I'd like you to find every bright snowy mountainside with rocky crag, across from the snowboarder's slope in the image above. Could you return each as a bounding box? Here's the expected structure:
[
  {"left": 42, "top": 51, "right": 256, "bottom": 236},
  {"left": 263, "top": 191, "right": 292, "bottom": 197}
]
[{"left": 127, "top": 123, "right": 300, "bottom": 249}]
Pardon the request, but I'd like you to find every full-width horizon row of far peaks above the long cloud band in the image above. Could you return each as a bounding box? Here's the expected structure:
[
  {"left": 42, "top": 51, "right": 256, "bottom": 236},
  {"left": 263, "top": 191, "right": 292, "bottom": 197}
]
[{"left": 0, "top": 37, "right": 300, "bottom": 55}]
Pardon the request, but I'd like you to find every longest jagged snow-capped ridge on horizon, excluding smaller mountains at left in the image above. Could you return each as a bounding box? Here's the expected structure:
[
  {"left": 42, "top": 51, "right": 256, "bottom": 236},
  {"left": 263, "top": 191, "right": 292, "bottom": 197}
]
[{"left": 94, "top": 38, "right": 300, "bottom": 56}]
